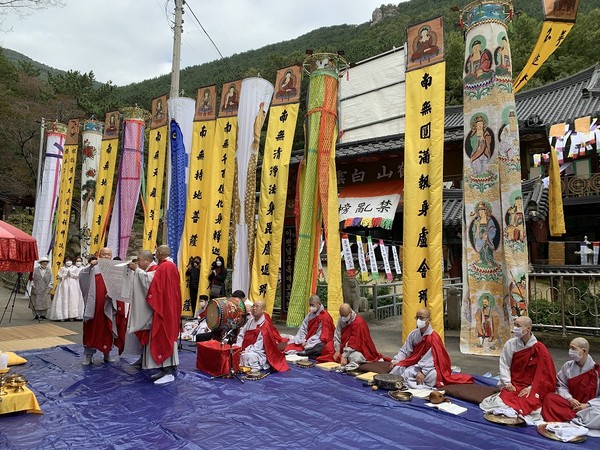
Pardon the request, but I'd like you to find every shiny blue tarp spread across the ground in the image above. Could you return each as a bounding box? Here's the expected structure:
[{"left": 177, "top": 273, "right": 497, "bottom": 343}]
[{"left": 0, "top": 345, "right": 600, "bottom": 450}]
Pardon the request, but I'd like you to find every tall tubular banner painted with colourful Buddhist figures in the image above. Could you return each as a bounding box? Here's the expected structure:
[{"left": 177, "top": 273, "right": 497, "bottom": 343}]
[{"left": 460, "top": 0, "right": 528, "bottom": 355}]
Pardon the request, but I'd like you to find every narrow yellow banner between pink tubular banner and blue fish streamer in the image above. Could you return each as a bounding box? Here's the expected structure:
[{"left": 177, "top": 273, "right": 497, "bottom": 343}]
[{"left": 142, "top": 95, "right": 169, "bottom": 251}]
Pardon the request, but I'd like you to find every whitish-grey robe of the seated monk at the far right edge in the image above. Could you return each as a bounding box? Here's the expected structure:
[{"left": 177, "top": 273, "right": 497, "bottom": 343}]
[{"left": 556, "top": 355, "right": 600, "bottom": 437}]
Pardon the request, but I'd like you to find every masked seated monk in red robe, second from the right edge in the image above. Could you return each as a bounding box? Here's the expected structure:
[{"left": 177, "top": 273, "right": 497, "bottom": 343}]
[{"left": 479, "top": 316, "right": 556, "bottom": 420}]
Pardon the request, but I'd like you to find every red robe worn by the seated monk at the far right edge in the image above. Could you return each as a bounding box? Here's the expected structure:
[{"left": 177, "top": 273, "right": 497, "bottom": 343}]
[{"left": 542, "top": 364, "right": 600, "bottom": 422}]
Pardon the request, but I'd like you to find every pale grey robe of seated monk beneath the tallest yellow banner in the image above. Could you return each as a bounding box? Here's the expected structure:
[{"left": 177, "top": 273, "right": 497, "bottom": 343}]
[{"left": 390, "top": 325, "right": 437, "bottom": 389}]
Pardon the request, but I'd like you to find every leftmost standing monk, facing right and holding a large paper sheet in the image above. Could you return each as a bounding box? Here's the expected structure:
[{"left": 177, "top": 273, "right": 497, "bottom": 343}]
[{"left": 79, "top": 247, "right": 117, "bottom": 366}]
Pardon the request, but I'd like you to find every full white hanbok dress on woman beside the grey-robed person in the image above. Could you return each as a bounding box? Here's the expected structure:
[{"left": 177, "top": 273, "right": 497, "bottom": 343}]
[{"left": 49, "top": 266, "right": 83, "bottom": 320}]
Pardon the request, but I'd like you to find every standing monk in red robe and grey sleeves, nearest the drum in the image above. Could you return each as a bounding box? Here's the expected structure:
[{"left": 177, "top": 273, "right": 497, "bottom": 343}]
[{"left": 129, "top": 245, "right": 182, "bottom": 385}]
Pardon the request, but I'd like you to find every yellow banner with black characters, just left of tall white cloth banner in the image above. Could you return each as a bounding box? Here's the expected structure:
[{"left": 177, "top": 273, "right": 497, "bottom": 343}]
[{"left": 198, "top": 80, "right": 242, "bottom": 295}]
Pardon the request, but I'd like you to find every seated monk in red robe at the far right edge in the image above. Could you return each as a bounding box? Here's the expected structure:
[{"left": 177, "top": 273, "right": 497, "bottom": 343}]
[{"left": 542, "top": 337, "right": 600, "bottom": 430}]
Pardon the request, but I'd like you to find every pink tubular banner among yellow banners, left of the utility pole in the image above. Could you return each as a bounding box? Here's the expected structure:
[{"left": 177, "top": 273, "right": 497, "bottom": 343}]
[{"left": 108, "top": 106, "right": 148, "bottom": 260}]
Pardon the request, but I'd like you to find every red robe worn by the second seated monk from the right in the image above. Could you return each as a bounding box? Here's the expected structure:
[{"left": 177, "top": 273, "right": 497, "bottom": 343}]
[{"left": 500, "top": 342, "right": 556, "bottom": 416}]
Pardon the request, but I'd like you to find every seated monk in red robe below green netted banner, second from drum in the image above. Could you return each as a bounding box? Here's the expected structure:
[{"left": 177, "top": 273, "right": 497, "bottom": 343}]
[{"left": 285, "top": 295, "right": 334, "bottom": 357}]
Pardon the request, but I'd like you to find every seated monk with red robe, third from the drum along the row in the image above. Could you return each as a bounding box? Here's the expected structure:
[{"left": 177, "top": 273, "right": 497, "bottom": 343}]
[{"left": 317, "top": 303, "right": 383, "bottom": 366}]
